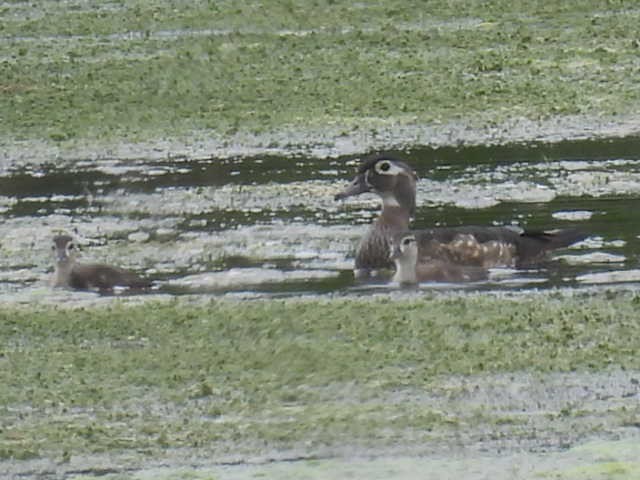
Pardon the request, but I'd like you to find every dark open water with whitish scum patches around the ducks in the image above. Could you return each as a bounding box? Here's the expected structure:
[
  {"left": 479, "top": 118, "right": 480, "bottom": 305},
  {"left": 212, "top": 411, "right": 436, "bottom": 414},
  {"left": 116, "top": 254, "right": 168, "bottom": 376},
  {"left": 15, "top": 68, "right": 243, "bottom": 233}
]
[{"left": 0, "top": 138, "right": 640, "bottom": 295}]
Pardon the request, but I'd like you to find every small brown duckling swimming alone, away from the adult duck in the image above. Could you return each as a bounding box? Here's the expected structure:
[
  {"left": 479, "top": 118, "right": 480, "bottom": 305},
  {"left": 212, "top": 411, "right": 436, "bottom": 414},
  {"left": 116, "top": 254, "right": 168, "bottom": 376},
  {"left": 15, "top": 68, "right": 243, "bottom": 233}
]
[{"left": 51, "top": 235, "right": 151, "bottom": 291}]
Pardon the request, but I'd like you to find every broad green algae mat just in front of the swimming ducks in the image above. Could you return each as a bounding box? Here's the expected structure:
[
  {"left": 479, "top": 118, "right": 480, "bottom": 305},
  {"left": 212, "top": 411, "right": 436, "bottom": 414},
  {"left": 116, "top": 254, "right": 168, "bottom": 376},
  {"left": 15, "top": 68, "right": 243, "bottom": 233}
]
[{"left": 0, "top": 294, "right": 640, "bottom": 459}]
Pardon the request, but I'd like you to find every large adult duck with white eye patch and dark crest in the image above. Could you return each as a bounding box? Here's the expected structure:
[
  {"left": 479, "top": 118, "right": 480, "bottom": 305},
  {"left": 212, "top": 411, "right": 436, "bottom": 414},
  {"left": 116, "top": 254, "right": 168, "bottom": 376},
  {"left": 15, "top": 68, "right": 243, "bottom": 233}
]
[{"left": 335, "top": 155, "right": 587, "bottom": 278}]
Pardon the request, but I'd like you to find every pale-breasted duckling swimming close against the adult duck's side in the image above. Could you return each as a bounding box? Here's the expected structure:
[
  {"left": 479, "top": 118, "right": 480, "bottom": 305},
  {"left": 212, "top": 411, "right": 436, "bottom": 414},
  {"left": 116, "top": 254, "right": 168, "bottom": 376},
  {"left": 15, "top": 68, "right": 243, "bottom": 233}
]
[{"left": 390, "top": 232, "right": 487, "bottom": 285}]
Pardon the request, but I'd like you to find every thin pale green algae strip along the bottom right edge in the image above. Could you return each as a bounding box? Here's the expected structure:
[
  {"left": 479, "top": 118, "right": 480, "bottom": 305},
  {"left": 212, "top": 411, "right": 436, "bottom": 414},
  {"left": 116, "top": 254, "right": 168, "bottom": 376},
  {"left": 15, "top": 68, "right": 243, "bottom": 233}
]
[{"left": 110, "top": 440, "right": 640, "bottom": 480}]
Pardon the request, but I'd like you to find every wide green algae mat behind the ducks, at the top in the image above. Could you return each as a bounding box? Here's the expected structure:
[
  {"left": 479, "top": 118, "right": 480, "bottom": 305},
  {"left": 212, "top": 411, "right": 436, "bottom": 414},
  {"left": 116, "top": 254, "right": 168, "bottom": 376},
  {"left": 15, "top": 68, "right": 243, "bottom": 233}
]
[{"left": 0, "top": 0, "right": 640, "bottom": 143}]
